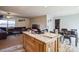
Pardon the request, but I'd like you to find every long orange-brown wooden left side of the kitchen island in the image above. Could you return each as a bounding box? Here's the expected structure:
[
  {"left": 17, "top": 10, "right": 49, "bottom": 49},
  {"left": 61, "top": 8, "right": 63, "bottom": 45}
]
[{"left": 23, "top": 34, "right": 45, "bottom": 52}]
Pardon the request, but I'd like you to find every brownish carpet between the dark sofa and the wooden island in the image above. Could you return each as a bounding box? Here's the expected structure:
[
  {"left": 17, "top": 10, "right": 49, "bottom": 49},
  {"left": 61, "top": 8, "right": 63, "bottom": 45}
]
[{"left": 0, "top": 34, "right": 23, "bottom": 49}]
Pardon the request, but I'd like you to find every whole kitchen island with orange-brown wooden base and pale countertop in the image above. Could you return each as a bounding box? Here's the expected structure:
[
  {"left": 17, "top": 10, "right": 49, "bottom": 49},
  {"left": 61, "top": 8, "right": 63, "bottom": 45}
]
[{"left": 23, "top": 32, "right": 61, "bottom": 52}]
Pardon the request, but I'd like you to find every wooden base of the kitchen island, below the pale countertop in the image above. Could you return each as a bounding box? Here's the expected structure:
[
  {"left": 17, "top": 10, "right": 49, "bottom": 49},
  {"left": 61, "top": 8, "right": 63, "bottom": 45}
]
[{"left": 23, "top": 34, "right": 59, "bottom": 52}]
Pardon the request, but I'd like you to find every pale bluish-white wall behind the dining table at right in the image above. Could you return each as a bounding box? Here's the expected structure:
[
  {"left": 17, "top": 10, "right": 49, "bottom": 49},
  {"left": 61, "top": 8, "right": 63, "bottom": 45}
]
[{"left": 54, "top": 14, "right": 79, "bottom": 36}]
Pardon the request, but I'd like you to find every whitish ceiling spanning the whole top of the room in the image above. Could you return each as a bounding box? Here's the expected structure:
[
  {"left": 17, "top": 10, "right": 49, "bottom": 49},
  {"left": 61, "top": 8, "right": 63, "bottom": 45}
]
[{"left": 0, "top": 6, "right": 79, "bottom": 17}]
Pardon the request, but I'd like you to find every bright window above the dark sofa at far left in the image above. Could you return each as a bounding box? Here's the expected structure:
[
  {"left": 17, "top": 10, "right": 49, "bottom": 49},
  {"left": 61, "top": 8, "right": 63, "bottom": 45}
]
[{"left": 0, "top": 19, "right": 15, "bottom": 27}]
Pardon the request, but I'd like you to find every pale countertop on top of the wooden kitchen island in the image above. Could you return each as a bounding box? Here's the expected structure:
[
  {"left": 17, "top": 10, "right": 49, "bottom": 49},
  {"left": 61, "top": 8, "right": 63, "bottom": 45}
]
[{"left": 23, "top": 31, "right": 61, "bottom": 43}]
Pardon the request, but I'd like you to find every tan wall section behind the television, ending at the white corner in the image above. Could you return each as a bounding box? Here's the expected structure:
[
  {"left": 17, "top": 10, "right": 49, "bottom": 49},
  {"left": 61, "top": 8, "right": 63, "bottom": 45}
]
[{"left": 31, "top": 16, "right": 47, "bottom": 30}]
